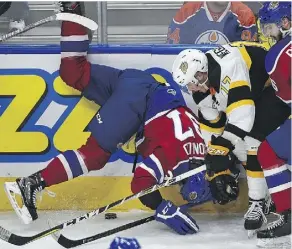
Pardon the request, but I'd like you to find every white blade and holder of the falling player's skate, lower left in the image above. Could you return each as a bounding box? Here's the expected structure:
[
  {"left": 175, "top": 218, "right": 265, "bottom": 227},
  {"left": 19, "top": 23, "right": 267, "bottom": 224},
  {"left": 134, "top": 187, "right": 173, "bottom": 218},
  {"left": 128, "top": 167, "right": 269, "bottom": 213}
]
[{"left": 4, "top": 182, "right": 32, "bottom": 225}]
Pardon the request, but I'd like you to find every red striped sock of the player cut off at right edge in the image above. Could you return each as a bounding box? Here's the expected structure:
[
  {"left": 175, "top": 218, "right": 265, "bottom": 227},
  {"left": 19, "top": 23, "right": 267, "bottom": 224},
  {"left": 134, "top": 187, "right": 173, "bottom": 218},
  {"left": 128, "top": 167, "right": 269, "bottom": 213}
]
[{"left": 258, "top": 141, "right": 291, "bottom": 212}]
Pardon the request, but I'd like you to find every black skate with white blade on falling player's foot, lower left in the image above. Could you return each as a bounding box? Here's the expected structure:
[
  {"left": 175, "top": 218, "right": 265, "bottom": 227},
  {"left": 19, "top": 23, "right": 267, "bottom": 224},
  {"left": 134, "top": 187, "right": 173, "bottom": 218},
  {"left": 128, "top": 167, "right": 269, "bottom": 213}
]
[{"left": 4, "top": 172, "right": 45, "bottom": 224}]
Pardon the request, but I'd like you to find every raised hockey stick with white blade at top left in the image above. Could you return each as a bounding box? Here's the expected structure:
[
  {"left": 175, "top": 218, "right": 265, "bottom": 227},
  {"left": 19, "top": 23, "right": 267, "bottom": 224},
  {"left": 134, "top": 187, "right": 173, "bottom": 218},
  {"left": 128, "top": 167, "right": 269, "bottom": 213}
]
[{"left": 0, "top": 13, "right": 98, "bottom": 42}]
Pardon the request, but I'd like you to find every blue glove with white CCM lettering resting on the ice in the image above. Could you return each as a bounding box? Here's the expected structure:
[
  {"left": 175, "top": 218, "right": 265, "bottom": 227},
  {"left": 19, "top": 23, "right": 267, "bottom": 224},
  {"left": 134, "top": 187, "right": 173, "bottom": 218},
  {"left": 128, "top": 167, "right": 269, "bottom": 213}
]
[{"left": 155, "top": 200, "right": 199, "bottom": 235}]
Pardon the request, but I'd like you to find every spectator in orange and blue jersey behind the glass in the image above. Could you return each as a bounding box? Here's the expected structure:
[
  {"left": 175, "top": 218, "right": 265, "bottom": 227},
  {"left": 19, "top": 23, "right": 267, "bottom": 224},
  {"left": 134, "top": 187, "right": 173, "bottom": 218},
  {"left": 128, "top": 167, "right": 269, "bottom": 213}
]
[{"left": 167, "top": 1, "right": 257, "bottom": 44}]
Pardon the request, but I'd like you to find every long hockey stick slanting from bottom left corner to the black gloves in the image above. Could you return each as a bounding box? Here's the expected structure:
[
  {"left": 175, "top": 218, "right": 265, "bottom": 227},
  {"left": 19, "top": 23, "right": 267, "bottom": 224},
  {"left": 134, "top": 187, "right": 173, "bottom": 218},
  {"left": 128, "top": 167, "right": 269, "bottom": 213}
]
[{"left": 0, "top": 165, "right": 206, "bottom": 246}]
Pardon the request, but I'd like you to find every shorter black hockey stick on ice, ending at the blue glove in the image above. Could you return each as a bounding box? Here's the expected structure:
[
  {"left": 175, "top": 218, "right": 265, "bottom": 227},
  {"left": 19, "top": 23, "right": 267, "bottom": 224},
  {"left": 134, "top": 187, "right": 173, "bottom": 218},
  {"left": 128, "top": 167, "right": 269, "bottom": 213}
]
[{"left": 52, "top": 215, "right": 155, "bottom": 248}]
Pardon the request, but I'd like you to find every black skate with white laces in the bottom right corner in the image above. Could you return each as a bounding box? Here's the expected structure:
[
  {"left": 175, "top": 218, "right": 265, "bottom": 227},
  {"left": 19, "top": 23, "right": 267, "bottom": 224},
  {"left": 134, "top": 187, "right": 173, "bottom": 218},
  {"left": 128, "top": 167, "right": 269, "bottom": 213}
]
[{"left": 257, "top": 209, "right": 291, "bottom": 249}]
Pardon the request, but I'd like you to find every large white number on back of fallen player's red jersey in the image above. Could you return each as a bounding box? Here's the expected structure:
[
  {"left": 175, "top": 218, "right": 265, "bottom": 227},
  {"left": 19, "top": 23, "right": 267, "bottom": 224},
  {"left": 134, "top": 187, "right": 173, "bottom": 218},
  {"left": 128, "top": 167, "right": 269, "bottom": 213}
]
[{"left": 167, "top": 110, "right": 202, "bottom": 141}]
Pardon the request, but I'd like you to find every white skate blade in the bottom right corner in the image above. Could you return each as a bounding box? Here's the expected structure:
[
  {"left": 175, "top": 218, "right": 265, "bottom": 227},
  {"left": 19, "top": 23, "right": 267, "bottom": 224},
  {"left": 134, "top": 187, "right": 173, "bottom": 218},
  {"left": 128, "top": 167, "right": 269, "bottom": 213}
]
[{"left": 257, "top": 235, "right": 291, "bottom": 249}]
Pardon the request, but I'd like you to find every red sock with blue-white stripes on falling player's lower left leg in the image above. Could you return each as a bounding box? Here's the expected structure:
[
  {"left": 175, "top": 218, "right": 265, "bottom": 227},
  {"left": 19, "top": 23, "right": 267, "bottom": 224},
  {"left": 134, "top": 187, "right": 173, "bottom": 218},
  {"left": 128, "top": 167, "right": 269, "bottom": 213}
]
[{"left": 41, "top": 136, "right": 110, "bottom": 186}]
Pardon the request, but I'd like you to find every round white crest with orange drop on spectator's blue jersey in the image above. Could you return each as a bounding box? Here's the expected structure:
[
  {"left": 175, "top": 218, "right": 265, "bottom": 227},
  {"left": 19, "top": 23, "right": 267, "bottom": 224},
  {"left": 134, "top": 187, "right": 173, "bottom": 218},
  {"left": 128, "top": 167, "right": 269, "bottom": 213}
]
[{"left": 195, "top": 30, "right": 229, "bottom": 45}]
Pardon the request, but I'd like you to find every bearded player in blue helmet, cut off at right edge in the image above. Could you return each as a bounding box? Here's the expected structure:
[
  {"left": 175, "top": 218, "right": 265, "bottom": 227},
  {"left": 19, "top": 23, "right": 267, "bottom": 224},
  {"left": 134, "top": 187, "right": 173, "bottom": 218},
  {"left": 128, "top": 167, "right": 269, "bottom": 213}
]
[{"left": 257, "top": 2, "right": 292, "bottom": 248}]
